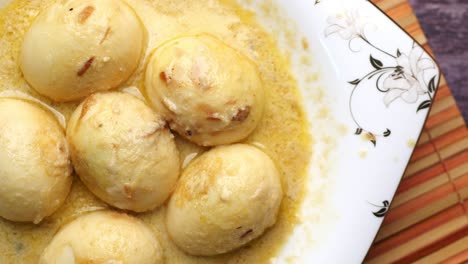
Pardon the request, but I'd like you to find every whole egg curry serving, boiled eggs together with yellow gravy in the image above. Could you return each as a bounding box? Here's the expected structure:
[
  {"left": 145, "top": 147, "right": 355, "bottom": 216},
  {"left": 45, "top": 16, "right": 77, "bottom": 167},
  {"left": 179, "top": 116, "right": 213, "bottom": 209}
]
[{"left": 0, "top": 0, "right": 311, "bottom": 264}]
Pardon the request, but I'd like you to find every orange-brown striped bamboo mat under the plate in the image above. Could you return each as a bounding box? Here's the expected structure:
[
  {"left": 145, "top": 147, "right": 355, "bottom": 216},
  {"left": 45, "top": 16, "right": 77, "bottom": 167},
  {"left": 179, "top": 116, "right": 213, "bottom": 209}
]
[{"left": 365, "top": 0, "right": 468, "bottom": 264}]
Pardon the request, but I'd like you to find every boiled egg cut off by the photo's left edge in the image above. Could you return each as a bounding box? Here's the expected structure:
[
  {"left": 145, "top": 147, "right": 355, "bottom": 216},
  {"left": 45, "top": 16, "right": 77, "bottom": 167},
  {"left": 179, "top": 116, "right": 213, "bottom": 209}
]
[{"left": 0, "top": 98, "right": 72, "bottom": 223}]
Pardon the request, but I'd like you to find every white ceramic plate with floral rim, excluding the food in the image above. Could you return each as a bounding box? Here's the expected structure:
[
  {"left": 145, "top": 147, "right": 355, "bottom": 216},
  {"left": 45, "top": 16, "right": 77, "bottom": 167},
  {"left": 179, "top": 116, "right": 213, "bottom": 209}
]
[{"left": 0, "top": 0, "right": 440, "bottom": 263}]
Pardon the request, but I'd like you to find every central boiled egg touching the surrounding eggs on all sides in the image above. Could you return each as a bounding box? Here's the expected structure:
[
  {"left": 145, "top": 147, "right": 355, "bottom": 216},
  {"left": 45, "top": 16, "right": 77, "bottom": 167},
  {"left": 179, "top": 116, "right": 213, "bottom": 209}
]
[{"left": 67, "top": 92, "right": 180, "bottom": 212}]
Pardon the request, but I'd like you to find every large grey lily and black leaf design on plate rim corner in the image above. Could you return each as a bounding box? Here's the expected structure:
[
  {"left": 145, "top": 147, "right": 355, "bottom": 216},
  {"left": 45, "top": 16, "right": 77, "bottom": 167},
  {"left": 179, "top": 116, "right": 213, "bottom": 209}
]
[{"left": 324, "top": 10, "right": 438, "bottom": 146}]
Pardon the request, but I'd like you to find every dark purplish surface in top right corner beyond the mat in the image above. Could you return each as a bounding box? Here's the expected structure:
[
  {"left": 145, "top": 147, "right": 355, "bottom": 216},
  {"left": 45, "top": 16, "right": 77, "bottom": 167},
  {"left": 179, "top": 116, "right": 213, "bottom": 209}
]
[{"left": 409, "top": 0, "right": 468, "bottom": 121}]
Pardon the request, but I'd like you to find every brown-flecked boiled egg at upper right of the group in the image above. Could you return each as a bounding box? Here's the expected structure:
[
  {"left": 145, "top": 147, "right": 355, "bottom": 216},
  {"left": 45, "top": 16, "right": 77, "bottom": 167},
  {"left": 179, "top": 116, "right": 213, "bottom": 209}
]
[{"left": 145, "top": 34, "right": 264, "bottom": 146}]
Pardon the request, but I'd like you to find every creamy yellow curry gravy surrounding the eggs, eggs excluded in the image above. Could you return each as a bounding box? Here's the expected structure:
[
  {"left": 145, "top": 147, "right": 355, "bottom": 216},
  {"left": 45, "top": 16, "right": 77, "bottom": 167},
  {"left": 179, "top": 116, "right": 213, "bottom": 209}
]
[{"left": 0, "top": 0, "right": 311, "bottom": 264}]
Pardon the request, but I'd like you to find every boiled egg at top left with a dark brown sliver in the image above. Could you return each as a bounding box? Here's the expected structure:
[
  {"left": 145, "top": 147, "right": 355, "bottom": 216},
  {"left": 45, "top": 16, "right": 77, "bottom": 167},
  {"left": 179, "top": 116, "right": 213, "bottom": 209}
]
[{"left": 20, "top": 0, "right": 146, "bottom": 101}]
